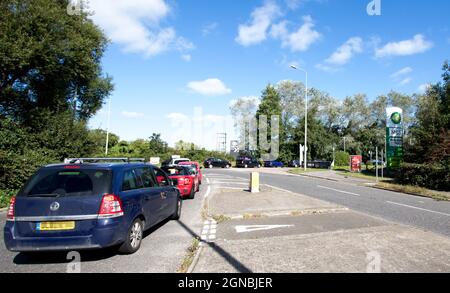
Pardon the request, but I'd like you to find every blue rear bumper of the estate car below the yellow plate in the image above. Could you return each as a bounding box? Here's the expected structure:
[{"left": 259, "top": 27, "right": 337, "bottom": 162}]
[{"left": 4, "top": 218, "right": 126, "bottom": 252}]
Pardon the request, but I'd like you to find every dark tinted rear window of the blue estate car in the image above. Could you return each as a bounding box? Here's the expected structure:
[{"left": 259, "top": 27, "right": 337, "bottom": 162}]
[{"left": 19, "top": 168, "right": 112, "bottom": 197}]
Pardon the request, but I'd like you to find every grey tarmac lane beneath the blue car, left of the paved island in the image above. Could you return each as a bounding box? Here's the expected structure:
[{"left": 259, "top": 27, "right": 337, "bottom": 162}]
[{"left": 0, "top": 184, "right": 208, "bottom": 273}]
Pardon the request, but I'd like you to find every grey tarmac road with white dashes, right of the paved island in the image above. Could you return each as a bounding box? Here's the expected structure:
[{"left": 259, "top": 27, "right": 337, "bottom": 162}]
[{"left": 205, "top": 169, "right": 450, "bottom": 237}]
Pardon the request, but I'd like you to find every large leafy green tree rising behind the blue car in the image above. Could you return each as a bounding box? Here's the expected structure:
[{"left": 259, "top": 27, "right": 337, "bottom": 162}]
[{"left": 0, "top": 0, "right": 113, "bottom": 121}]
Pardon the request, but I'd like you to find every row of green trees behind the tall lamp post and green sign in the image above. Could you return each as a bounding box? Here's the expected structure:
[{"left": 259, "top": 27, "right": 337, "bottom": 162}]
[{"left": 230, "top": 62, "right": 450, "bottom": 190}]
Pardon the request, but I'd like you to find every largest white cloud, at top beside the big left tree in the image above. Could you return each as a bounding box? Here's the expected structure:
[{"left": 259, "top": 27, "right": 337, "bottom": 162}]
[{"left": 89, "top": 0, "right": 194, "bottom": 57}]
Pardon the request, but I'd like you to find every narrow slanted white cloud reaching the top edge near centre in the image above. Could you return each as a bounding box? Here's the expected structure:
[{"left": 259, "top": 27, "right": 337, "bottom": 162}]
[{"left": 236, "top": 1, "right": 281, "bottom": 47}]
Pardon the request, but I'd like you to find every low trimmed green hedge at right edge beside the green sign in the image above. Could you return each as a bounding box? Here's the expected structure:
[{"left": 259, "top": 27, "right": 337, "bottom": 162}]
[{"left": 397, "top": 164, "right": 450, "bottom": 191}]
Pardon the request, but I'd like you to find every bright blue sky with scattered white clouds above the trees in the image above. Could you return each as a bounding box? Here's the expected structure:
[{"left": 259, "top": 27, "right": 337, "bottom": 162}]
[{"left": 87, "top": 0, "right": 450, "bottom": 149}]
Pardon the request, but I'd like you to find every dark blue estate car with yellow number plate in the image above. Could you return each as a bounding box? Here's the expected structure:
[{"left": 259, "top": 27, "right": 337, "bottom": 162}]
[{"left": 4, "top": 159, "right": 182, "bottom": 254}]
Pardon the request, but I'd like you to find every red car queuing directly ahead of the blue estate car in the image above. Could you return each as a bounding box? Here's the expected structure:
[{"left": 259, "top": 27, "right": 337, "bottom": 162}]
[{"left": 158, "top": 166, "right": 200, "bottom": 199}]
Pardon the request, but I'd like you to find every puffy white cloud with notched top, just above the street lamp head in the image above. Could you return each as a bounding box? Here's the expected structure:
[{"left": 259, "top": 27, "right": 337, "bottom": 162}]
[{"left": 271, "top": 16, "right": 322, "bottom": 52}]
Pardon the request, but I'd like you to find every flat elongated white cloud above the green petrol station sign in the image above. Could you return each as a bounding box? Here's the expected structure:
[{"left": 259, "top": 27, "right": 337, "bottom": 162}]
[{"left": 375, "top": 34, "right": 434, "bottom": 58}]
